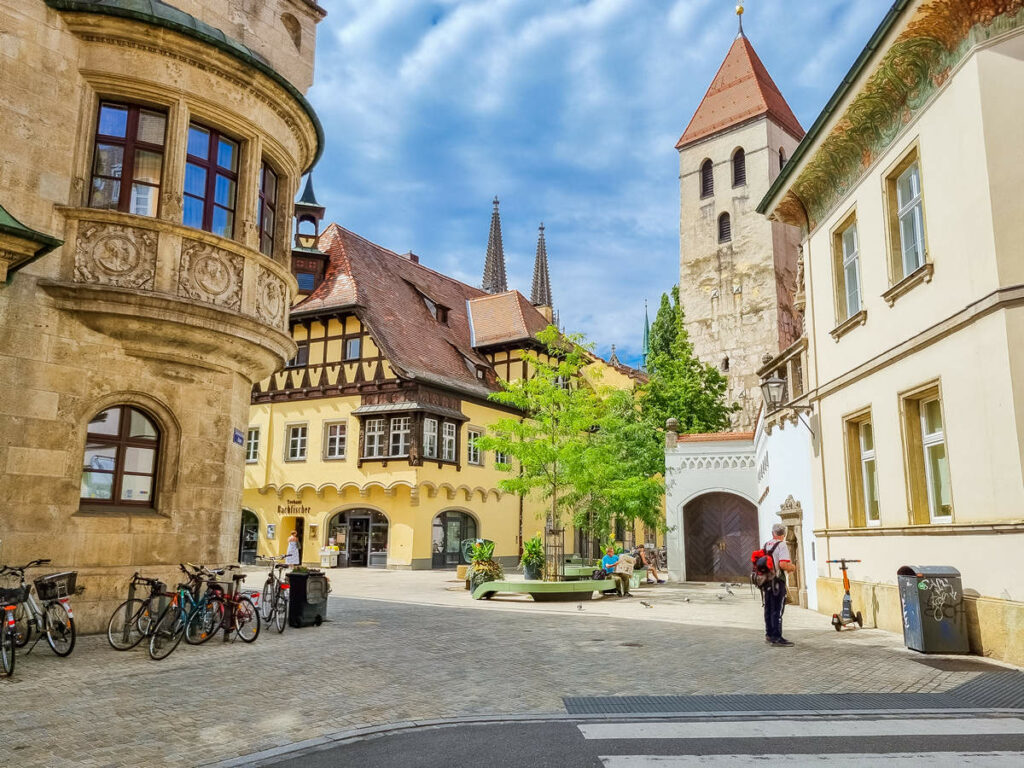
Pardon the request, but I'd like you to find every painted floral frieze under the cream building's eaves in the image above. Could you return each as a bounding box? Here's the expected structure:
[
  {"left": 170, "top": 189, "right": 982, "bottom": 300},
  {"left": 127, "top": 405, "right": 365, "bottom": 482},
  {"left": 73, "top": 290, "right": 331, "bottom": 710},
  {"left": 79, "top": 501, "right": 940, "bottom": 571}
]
[{"left": 775, "top": 0, "right": 1024, "bottom": 229}]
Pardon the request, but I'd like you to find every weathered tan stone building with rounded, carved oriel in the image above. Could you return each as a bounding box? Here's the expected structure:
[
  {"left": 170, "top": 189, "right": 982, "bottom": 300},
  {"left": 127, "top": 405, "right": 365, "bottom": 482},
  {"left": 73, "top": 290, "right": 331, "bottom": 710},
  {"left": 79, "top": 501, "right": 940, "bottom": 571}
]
[{"left": 0, "top": 0, "right": 325, "bottom": 630}]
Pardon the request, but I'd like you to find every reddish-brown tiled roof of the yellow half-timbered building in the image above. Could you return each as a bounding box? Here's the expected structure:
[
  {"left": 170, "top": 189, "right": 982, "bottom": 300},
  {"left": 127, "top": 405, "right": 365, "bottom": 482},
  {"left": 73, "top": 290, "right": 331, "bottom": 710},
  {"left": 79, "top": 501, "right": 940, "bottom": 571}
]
[{"left": 292, "top": 224, "right": 547, "bottom": 397}]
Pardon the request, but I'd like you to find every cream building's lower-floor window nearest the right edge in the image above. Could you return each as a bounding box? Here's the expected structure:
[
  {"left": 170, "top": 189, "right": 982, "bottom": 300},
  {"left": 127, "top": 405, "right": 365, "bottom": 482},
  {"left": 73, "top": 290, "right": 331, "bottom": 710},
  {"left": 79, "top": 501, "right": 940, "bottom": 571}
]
[{"left": 903, "top": 387, "right": 953, "bottom": 524}]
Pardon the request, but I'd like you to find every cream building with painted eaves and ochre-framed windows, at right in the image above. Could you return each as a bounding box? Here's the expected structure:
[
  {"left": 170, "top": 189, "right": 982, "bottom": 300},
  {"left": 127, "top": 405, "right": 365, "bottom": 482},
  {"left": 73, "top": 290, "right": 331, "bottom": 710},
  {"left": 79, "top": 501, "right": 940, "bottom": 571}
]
[{"left": 760, "top": 0, "right": 1024, "bottom": 664}]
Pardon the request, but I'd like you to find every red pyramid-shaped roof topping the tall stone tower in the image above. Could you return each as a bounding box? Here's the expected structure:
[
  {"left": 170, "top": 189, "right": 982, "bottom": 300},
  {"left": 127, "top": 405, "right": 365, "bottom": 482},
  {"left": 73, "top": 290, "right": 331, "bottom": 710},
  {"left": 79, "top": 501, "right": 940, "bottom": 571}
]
[{"left": 676, "top": 33, "right": 804, "bottom": 150}]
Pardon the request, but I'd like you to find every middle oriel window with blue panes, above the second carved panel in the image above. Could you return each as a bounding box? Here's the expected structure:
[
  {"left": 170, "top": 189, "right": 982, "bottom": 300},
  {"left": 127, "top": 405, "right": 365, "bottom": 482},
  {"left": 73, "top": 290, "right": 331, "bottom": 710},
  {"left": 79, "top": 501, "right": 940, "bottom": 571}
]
[{"left": 182, "top": 123, "right": 239, "bottom": 238}]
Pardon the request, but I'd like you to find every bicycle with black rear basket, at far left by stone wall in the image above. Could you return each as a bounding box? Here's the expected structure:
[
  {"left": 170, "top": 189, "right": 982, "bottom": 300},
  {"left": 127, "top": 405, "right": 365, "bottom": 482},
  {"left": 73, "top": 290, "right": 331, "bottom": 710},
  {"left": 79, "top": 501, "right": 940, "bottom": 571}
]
[{"left": 0, "top": 560, "right": 82, "bottom": 657}]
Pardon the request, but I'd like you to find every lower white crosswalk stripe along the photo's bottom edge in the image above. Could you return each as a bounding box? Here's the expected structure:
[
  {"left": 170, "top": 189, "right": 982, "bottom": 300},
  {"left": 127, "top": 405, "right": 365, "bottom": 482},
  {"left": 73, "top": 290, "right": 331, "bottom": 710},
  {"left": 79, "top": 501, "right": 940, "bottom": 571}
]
[{"left": 601, "top": 752, "right": 1024, "bottom": 768}]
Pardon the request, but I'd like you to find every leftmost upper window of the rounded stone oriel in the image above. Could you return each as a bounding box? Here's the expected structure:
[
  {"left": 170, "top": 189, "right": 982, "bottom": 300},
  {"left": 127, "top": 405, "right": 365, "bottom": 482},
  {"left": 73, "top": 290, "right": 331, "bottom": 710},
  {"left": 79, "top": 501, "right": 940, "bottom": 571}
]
[{"left": 89, "top": 101, "right": 167, "bottom": 216}]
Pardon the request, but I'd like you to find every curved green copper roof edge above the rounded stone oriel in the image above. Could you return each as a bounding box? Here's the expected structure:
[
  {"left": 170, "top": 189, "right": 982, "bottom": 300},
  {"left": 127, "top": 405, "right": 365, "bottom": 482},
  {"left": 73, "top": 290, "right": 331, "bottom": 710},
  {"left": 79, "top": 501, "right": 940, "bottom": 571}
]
[{"left": 45, "top": 0, "right": 325, "bottom": 170}]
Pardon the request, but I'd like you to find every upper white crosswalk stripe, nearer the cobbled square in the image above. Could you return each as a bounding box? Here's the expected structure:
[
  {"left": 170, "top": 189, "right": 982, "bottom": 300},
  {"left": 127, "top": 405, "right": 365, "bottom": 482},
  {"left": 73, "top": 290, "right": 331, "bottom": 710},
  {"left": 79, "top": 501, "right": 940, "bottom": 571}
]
[{"left": 578, "top": 718, "right": 1024, "bottom": 739}]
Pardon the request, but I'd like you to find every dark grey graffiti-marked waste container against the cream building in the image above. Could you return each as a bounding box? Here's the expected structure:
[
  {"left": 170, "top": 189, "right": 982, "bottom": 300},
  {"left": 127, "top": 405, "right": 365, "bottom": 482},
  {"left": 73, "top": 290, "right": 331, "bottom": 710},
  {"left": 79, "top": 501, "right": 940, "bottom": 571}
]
[{"left": 896, "top": 565, "right": 971, "bottom": 653}]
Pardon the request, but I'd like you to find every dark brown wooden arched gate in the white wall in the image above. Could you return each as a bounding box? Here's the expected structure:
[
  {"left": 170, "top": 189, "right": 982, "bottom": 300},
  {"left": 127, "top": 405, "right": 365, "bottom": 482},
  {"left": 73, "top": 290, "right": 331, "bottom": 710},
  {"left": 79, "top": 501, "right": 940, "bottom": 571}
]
[{"left": 683, "top": 493, "right": 758, "bottom": 582}]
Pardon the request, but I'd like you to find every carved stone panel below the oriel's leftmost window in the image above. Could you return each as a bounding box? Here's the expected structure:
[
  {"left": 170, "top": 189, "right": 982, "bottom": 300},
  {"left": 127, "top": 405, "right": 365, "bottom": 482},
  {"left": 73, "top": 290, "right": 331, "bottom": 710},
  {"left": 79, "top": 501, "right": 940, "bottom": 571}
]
[{"left": 75, "top": 221, "right": 157, "bottom": 291}]
